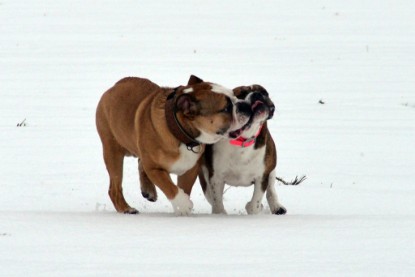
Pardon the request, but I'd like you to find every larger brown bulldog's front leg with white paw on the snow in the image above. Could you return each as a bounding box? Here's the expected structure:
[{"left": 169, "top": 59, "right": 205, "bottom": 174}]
[{"left": 145, "top": 166, "right": 193, "bottom": 215}]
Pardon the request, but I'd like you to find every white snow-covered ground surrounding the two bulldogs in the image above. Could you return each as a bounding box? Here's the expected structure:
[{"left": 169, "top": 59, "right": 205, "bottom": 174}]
[{"left": 0, "top": 0, "right": 415, "bottom": 276}]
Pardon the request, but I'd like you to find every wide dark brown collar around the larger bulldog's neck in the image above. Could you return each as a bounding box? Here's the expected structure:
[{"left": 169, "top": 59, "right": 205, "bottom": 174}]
[{"left": 165, "top": 89, "right": 200, "bottom": 152}]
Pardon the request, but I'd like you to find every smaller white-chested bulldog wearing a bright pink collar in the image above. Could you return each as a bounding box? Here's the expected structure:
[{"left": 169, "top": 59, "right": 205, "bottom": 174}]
[{"left": 199, "top": 85, "right": 287, "bottom": 214}]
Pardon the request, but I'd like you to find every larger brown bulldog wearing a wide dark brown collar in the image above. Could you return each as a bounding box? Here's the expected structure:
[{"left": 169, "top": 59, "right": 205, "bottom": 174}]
[{"left": 96, "top": 75, "right": 251, "bottom": 215}]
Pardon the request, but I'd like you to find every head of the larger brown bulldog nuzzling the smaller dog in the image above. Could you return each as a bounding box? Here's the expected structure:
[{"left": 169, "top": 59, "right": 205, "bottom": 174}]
[{"left": 176, "top": 75, "right": 252, "bottom": 144}]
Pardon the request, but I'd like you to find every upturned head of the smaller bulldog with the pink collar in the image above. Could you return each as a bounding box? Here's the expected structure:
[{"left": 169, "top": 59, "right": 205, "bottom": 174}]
[{"left": 229, "top": 85, "right": 275, "bottom": 138}]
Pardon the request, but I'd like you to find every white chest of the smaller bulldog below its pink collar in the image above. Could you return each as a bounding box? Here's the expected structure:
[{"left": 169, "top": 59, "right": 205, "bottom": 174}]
[{"left": 213, "top": 140, "right": 265, "bottom": 186}]
